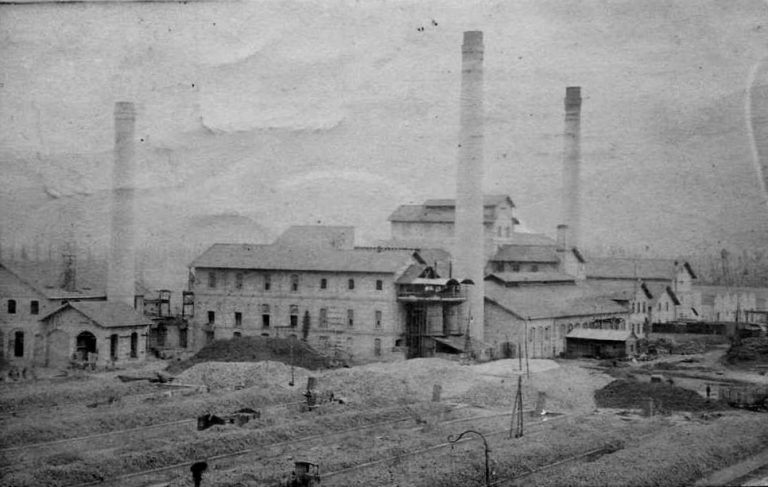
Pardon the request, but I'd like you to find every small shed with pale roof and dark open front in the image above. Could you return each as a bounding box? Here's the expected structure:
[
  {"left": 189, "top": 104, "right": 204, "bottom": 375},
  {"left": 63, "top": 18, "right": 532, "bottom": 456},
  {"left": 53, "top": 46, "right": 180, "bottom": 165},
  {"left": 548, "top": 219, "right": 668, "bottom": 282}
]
[{"left": 565, "top": 328, "right": 637, "bottom": 358}]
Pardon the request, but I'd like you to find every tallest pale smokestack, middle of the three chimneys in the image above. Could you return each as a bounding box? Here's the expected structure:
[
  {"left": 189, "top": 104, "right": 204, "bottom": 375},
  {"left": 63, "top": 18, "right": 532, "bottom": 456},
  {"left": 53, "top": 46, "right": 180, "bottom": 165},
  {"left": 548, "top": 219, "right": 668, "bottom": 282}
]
[{"left": 453, "top": 31, "right": 485, "bottom": 341}]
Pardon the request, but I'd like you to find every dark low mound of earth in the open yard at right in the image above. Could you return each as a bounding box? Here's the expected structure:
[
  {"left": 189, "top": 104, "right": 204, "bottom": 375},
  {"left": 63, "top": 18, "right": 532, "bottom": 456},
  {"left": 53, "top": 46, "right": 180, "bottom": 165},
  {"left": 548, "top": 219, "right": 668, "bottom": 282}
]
[{"left": 595, "top": 380, "right": 728, "bottom": 412}]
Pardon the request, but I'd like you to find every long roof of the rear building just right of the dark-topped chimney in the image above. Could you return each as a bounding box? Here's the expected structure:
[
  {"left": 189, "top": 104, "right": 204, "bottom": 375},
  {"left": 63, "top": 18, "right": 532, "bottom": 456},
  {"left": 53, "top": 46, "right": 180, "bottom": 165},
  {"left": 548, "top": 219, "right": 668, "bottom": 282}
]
[{"left": 587, "top": 257, "right": 696, "bottom": 281}]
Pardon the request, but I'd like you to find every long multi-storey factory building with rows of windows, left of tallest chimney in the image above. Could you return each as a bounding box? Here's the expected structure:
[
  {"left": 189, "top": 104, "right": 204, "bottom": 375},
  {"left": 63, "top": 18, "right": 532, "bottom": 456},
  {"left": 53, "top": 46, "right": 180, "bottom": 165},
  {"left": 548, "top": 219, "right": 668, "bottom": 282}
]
[{"left": 190, "top": 226, "right": 465, "bottom": 360}]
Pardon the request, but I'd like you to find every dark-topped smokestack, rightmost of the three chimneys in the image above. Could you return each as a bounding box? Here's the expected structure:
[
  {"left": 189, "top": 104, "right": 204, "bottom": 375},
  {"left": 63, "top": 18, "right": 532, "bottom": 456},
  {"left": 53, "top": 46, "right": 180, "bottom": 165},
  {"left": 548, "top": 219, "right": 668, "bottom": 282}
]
[{"left": 561, "top": 86, "right": 581, "bottom": 247}]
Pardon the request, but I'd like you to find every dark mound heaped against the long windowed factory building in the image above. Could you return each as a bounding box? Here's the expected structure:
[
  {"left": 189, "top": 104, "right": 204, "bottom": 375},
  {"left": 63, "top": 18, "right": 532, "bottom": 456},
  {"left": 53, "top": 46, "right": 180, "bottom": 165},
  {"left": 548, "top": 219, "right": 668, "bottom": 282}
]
[{"left": 168, "top": 337, "right": 332, "bottom": 374}]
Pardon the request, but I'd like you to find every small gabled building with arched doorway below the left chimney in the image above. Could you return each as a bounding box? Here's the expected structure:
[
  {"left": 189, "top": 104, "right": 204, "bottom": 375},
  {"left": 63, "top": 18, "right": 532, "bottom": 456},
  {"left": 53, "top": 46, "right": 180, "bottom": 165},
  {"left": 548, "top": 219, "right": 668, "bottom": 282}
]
[{"left": 36, "top": 301, "right": 152, "bottom": 367}]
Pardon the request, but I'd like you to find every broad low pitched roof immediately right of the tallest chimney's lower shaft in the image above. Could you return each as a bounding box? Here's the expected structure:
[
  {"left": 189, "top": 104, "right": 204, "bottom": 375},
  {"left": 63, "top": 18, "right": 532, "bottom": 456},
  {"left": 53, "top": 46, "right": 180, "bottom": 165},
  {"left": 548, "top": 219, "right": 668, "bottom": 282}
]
[{"left": 485, "top": 281, "right": 627, "bottom": 319}]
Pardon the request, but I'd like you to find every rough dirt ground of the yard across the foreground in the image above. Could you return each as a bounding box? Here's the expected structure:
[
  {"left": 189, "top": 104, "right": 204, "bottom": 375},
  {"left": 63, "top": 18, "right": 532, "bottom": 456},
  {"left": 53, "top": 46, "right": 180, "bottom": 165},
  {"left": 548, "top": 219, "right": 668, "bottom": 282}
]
[{"left": 0, "top": 345, "right": 768, "bottom": 486}]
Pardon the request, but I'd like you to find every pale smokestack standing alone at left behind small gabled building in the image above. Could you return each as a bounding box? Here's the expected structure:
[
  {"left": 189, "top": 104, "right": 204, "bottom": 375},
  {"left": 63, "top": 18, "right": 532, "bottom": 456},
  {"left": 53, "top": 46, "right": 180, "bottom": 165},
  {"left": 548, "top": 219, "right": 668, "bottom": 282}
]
[{"left": 107, "top": 102, "right": 136, "bottom": 307}]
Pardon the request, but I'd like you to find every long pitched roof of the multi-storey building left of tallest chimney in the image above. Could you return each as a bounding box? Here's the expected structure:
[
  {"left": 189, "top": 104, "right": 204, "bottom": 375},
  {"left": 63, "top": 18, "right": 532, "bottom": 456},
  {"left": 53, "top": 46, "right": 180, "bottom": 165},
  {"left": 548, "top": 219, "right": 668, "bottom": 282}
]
[{"left": 192, "top": 244, "right": 414, "bottom": 274}]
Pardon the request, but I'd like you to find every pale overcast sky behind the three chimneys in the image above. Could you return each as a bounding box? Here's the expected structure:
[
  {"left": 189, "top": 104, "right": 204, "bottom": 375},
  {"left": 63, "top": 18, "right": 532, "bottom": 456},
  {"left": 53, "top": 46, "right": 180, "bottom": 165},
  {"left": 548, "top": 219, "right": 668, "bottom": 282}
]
[{"left": 0, "top": 0, "right": 768, "bottom": 264}]
